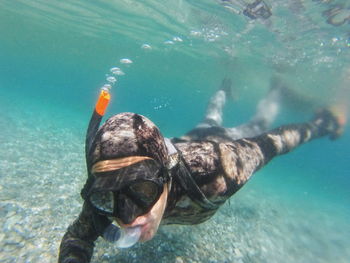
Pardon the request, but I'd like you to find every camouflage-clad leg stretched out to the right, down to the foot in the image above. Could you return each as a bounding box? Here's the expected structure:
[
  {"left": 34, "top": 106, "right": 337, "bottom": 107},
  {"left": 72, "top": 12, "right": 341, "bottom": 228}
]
[{"left": 219, "top": 109, "right": 344, "bottom": 196}]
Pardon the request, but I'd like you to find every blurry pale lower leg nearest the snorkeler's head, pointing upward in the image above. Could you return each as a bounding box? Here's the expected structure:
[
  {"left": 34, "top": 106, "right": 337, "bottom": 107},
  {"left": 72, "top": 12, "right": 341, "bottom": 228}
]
[{"left": 196, "top": 78, "right": 232, "bottom": 128}]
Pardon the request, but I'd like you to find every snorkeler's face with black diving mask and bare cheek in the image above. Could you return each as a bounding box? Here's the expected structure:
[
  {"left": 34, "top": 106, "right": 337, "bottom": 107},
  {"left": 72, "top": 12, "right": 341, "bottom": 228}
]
[{"left": 89, "top": 156, "right": 168, "bottom": 241}]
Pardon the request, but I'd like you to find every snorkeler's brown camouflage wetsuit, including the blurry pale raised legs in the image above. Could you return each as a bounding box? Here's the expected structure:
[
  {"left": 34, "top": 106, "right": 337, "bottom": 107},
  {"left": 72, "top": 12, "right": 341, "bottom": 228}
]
[{"left": 59, "top": 80, "right": 339, "bottom": 262}]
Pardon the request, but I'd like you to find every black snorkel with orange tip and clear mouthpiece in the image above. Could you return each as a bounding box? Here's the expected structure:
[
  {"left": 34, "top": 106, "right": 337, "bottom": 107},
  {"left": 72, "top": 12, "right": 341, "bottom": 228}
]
[{"left": 85, "top": 84, "right": 141, "bottom": 248}]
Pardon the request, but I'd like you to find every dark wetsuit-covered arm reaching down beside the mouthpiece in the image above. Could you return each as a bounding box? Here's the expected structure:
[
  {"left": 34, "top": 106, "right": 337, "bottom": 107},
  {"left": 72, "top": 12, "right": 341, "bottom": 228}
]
[{"left": 58, "top": 203, "right": 103, "bottom": 263}]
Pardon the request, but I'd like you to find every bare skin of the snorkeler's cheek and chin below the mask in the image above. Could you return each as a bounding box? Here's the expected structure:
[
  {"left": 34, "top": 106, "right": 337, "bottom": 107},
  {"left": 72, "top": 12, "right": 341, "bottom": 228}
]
[{"left": 116, "top": 184, "right": 168, "bottom": 242}]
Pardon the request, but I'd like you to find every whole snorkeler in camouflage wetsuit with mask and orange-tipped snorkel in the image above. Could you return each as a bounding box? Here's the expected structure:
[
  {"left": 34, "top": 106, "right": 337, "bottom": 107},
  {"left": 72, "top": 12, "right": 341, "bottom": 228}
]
[{"left": 58, "top": 79, "right": 345, "bottom": 263}]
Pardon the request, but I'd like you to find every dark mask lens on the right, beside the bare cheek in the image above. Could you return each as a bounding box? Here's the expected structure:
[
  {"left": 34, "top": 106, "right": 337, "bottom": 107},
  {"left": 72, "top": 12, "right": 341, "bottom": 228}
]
[{"left": 129, "top": 181, "right": 159, "bottom": 206}]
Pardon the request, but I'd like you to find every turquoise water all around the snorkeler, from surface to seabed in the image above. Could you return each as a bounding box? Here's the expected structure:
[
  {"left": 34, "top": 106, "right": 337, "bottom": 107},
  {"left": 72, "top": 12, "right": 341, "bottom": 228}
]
[{"left": 0, "top": 0, "right": 350, "bottom": 263}]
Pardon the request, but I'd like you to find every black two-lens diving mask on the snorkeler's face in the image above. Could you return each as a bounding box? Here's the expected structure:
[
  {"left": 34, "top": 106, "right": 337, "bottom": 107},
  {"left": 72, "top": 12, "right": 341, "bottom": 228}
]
[{"left": 88, "top": 157, "right": 167, "bottom": 224}]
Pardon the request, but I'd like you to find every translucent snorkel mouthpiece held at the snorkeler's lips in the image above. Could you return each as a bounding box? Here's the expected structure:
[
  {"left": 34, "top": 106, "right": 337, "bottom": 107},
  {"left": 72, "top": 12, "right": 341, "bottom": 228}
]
[{"left": 103, "top": 223, "right": 141, "bottom": 248}]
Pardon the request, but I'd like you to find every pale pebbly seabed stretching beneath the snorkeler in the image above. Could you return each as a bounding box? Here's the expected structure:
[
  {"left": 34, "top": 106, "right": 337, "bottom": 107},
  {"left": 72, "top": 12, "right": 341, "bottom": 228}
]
[{"left": 0, "top": 101, "right": 350, "bottom": 263}]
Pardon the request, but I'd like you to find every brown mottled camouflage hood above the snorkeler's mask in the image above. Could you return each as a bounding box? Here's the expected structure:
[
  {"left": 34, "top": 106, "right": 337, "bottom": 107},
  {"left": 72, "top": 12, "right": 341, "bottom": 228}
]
[{"left": 87, "top": 113, "right": 168, "bottom": 170}]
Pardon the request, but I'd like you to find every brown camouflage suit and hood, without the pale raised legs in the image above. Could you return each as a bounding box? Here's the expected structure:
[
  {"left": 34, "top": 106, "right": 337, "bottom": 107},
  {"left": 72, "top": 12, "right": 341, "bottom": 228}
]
[{"left": 59, "top": 110, "right": 339, "bottom": 263}]
